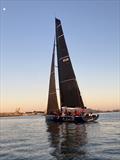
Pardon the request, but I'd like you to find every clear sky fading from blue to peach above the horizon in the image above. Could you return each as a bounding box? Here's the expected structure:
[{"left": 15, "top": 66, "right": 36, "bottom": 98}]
[{"left": 0, "top": 0, "right": 120, "bottom": 112}]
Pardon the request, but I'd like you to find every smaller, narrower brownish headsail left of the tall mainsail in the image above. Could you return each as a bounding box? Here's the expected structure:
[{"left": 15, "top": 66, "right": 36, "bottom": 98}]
[{"left": 47, "top": 40, "right": 59, "bottom": 115}]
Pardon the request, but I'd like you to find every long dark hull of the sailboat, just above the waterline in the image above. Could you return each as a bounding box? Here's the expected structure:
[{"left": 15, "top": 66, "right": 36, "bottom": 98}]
[{"left": 46, "top": 114, "right": 99, "bottom": 123}]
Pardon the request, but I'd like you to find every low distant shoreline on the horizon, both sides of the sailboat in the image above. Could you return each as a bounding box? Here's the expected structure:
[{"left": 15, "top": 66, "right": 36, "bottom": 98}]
[{"left": 0, "top": 109, "right": 120, "bottom": 117}]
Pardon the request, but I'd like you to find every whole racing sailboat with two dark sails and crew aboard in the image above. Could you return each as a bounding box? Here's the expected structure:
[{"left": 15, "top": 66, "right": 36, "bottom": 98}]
[{"left": 46, "top": 18, "right": 99, "bottom": 122}]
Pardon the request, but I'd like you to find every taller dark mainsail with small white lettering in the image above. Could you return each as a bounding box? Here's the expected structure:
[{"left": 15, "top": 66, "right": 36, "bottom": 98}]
[{"left": 55, "top": 19, "right": 84, "bottom": 108}]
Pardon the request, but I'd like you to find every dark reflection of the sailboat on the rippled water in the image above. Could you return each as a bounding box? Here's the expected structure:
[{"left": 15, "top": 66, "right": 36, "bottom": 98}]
[{"left": 47, "top": 123, "right": 87, "bottom": 160}]
